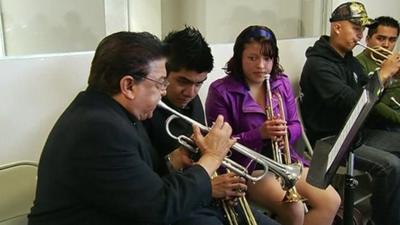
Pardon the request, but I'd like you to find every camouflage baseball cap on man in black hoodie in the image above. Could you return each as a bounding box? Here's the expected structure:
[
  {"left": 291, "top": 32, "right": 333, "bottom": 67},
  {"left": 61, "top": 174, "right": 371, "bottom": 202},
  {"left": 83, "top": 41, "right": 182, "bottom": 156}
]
[{"left": 329, "top": 2, "right": 375, "bottom": 26}]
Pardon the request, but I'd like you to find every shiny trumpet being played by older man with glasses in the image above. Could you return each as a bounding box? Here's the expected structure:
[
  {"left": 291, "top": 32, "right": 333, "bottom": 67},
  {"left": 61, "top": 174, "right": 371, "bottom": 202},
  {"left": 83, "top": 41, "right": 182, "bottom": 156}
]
[{"left": 158, "top": 101, "right": 303, "bottom": 190}]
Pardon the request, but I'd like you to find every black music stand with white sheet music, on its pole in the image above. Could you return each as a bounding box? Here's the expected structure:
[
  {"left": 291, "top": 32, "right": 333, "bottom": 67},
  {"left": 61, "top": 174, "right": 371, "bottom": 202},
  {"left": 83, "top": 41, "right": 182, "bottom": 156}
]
[{"left": 307, "top": 82, "right": 381, "bottom": 225}]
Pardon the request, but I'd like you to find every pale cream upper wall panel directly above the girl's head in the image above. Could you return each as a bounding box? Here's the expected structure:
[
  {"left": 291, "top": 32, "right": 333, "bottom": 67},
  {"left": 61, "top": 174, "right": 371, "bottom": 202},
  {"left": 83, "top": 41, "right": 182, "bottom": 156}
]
[{"left": 202, "top": 0, "right": 302, "bottom": 43}]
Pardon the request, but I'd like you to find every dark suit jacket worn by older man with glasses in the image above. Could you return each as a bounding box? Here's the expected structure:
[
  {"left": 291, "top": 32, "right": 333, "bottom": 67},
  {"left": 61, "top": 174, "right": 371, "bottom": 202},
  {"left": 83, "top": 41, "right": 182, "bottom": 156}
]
[{"left": 29, "top": 88, "right": 211, "bottom": 225}]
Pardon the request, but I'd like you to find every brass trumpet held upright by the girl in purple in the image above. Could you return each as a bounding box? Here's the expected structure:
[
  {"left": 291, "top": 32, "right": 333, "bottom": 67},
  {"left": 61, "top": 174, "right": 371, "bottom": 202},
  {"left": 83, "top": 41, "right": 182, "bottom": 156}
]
[{"left": 265, "top": 74, "right": 304, "bottom": 202}]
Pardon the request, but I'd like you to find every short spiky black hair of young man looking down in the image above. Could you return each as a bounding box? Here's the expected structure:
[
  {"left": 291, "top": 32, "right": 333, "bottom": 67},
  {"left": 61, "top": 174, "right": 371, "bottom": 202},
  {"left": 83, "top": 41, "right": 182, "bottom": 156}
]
[{"left": 164, "top": 26, "right": 214, "bottom": 73}]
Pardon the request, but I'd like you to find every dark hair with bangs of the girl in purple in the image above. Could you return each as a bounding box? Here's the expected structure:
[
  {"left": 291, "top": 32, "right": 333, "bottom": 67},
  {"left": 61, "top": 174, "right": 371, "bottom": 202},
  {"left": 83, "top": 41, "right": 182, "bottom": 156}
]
[{"left": 225, "top": 25, "right": 283, "bottom": 80}]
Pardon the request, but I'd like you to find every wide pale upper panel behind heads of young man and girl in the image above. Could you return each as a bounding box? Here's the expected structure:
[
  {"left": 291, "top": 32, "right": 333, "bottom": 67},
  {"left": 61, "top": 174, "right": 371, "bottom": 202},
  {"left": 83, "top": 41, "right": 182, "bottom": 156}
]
[{"left": 161, "top": 0, "right": 312, "bottom": 43}]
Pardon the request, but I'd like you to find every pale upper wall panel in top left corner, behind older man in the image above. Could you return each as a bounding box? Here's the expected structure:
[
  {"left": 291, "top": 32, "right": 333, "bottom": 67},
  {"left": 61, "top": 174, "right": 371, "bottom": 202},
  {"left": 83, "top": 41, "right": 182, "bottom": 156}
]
[{"left": 1, "top": 0, "right": 105, "bottom": 56}]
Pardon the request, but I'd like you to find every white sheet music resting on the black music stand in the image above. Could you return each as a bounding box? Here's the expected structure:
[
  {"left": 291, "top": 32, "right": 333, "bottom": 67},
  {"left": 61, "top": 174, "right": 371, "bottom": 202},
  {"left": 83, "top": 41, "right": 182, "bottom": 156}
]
[{"left": 325, "top": 90, "right": 368, "bottom": 171}]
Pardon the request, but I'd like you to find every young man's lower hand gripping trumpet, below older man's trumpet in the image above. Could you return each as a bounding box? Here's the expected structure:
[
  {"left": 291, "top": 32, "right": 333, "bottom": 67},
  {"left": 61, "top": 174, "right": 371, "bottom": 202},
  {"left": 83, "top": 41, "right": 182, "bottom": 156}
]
[{"left": 211, "top": 173, "right": 247, "bottom": 200}]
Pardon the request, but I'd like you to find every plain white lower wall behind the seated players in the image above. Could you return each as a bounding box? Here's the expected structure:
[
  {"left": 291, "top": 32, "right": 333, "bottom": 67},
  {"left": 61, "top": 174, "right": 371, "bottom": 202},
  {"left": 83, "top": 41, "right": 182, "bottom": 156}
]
[{"left": 0, "top": 38, "right": 315, "bottom": 164}]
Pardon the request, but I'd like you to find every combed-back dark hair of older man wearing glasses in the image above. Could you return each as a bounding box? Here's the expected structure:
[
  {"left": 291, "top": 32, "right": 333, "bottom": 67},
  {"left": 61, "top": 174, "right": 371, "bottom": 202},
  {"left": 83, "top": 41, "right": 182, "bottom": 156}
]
[{"left": 88, "top": 31, "right": 166, "bottom": 95}]
